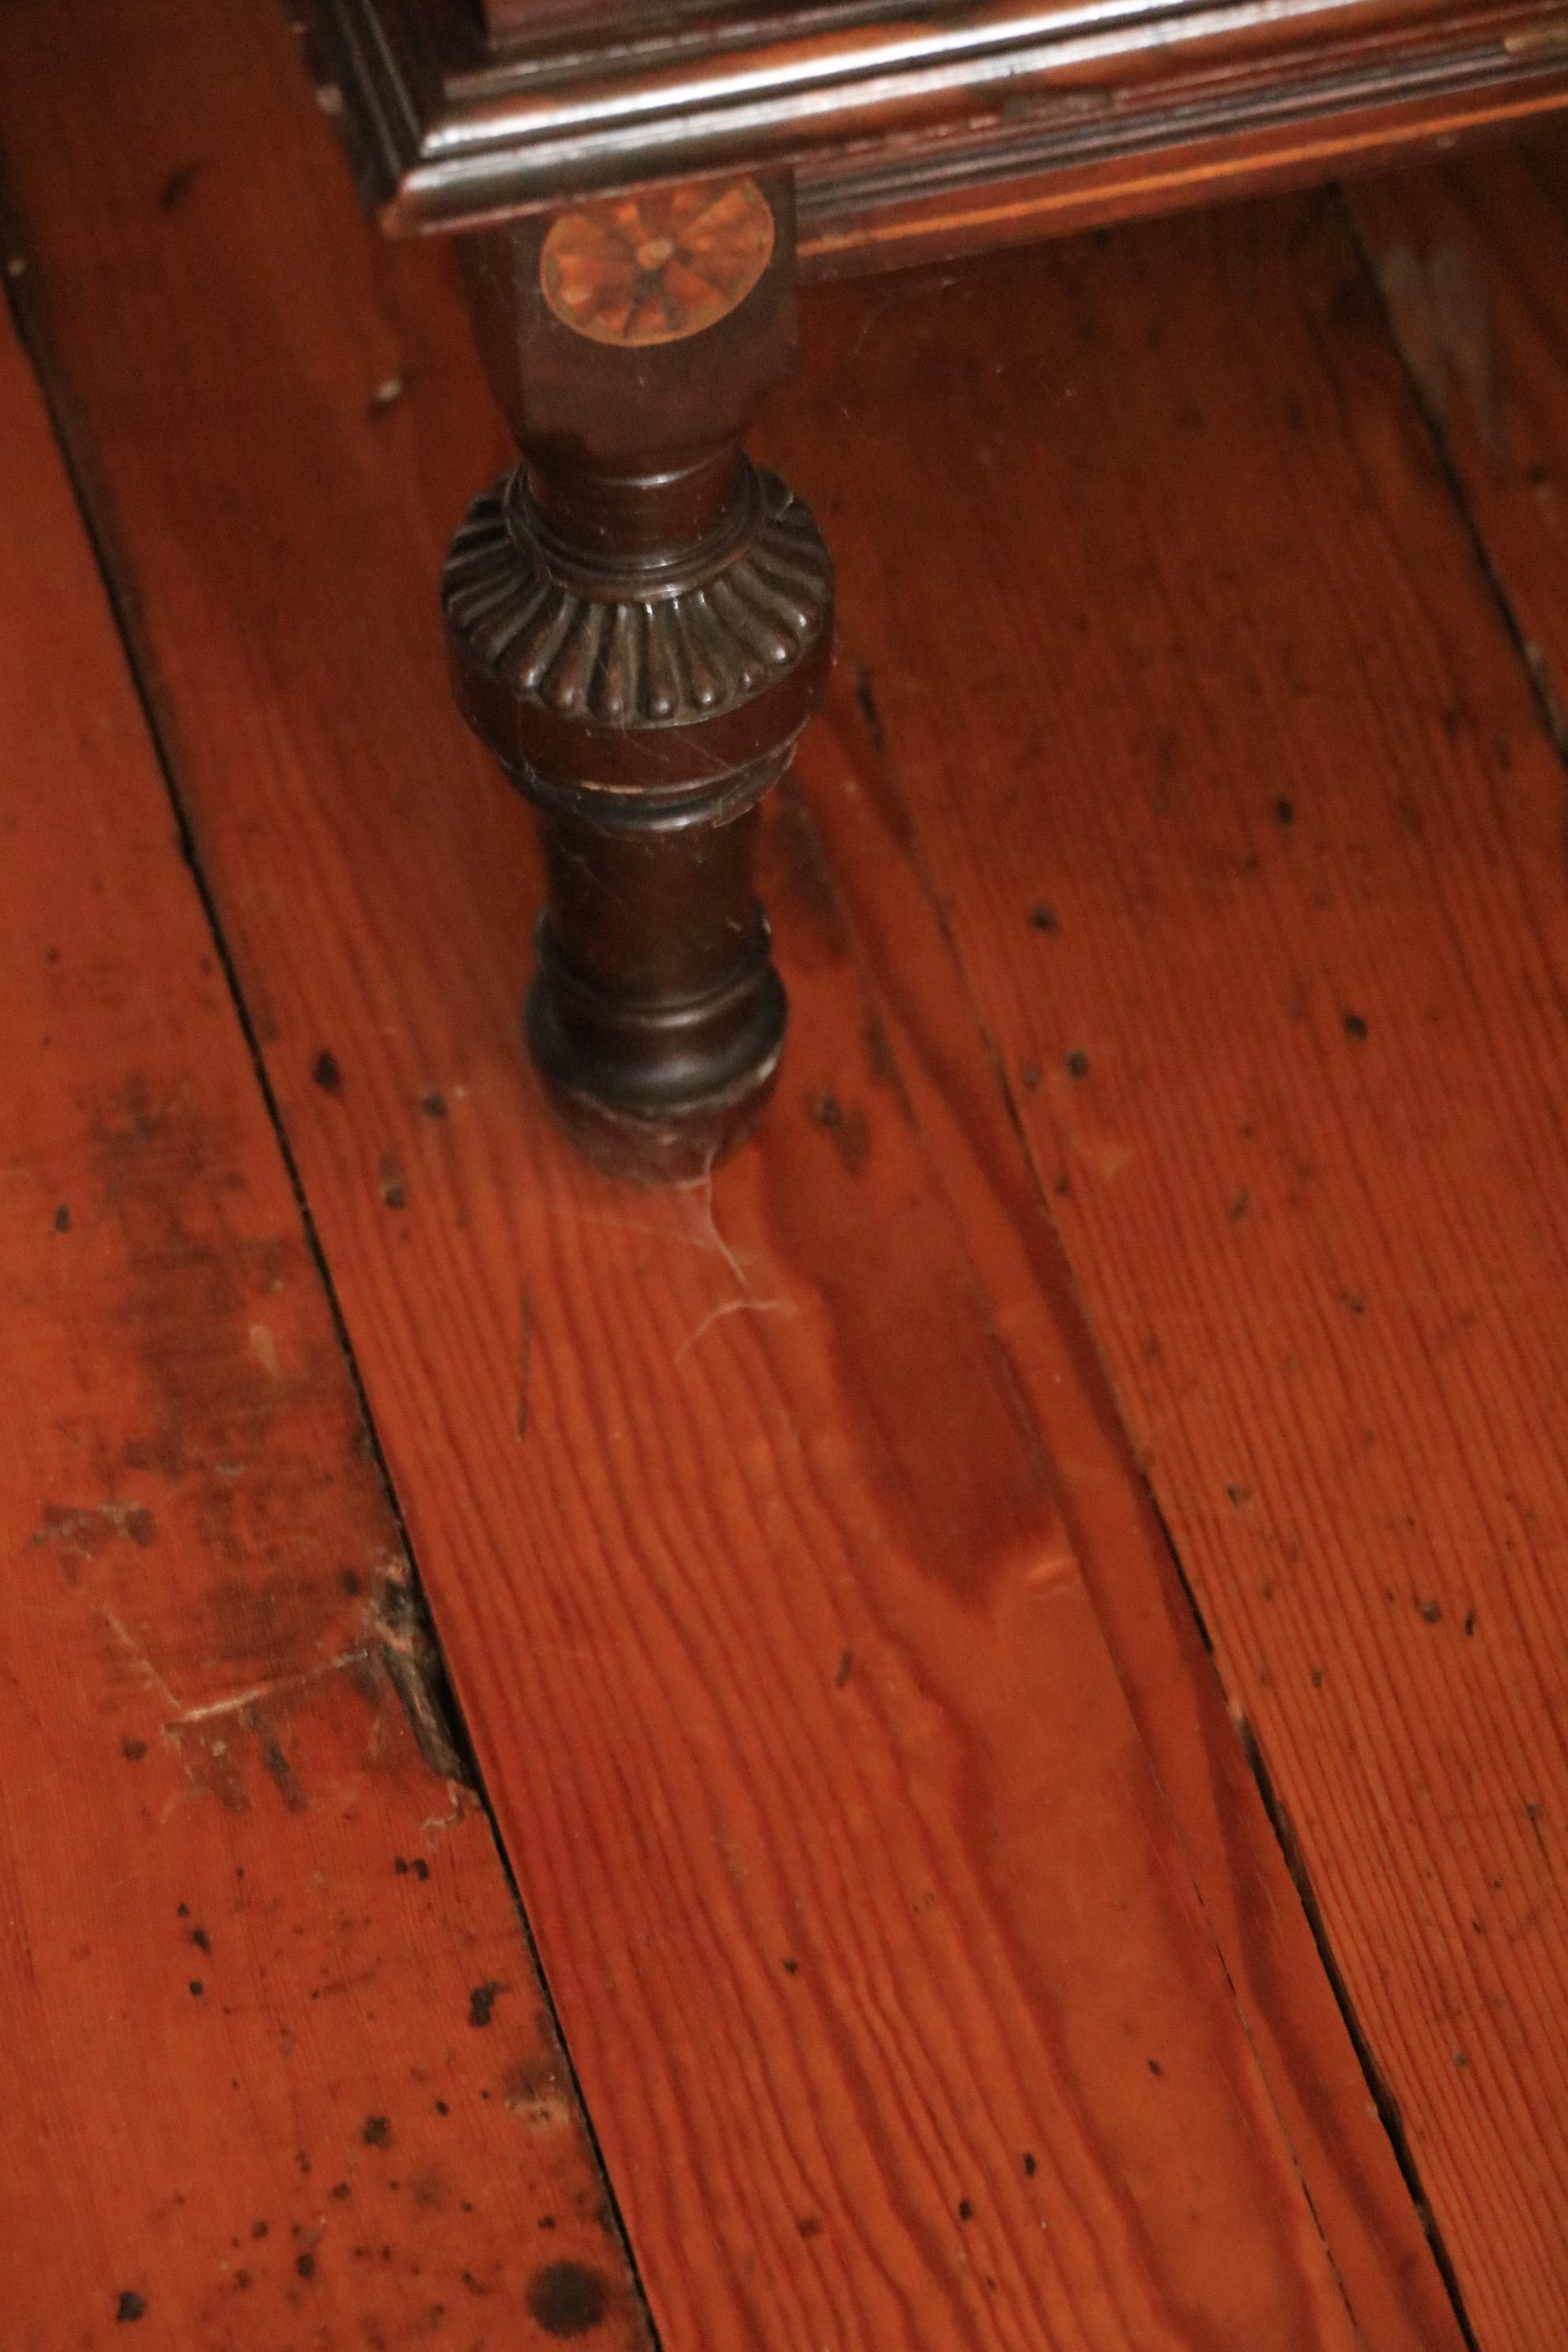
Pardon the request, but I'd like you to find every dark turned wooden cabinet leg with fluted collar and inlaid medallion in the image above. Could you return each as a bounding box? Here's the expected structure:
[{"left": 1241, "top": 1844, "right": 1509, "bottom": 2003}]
[{"left": 442, "top": 179, "right": 832, "bottom": 1181}]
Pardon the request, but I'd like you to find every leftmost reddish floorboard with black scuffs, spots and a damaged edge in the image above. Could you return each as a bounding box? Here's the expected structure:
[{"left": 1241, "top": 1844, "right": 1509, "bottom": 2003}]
[{"left": 0, "top": 298, "right": 644, "bottom": 2352}]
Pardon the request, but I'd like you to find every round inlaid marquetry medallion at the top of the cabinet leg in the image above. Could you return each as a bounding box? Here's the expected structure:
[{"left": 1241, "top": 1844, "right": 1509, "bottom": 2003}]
[{"left": 538, "top": 179, "right": 774, "bottom": 343}]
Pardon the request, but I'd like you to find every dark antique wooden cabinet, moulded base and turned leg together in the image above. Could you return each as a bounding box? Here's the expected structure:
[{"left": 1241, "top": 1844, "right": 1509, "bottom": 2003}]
[{"left": 303, "top": 0, "right": 1568, "bottom": 1178}]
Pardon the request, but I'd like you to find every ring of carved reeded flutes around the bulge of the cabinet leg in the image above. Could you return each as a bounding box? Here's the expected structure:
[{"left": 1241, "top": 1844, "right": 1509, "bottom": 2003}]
[{"left": 442, "top": 470, "right": 832, "bottom": 729}]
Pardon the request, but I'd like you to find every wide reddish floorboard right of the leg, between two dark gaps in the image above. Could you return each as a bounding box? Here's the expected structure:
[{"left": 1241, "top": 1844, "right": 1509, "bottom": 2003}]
[{"left": 752, "top": 174, "right": 1568, "bottom": 2352}]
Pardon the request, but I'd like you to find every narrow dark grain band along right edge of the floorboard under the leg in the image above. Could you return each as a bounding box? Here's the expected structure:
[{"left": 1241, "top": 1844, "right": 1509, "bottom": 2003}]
[{"left": 771, "top": 710, "right": 1462, "bottom": 2352}]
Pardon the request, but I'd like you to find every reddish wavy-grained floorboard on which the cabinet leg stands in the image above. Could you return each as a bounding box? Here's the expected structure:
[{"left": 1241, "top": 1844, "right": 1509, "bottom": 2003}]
[{"left": 0, "top": 0, "right": 1476, "bottom": 2352}]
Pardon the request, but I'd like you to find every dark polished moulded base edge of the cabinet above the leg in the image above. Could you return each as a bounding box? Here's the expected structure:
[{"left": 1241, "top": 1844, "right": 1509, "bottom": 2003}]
[{"left": 299, "top": 0, "right": 1568, "bottom": 258}]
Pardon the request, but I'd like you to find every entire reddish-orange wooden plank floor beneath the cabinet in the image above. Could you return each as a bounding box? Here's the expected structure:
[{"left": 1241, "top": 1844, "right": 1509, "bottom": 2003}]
[{"left": 0, "top": 0, "right": 1568, "bottom": 2352}]
